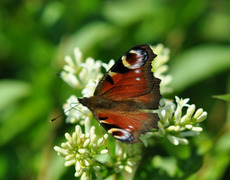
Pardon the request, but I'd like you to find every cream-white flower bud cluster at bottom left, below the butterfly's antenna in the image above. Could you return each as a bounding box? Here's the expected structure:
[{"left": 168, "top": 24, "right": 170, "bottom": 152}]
[{"left": 54, "top": 125, "right": 108, "bottom": 179}]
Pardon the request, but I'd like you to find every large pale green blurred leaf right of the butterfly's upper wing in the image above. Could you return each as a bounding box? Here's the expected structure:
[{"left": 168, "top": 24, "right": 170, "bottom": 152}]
[{"left": 169, "top": 45, "right": 230, "bottom": 92}]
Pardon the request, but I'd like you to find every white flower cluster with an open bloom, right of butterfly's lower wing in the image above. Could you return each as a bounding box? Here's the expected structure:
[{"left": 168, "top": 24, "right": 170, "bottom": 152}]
[{"left": 158, "top": 96, "right": 207, "bottom": 145}]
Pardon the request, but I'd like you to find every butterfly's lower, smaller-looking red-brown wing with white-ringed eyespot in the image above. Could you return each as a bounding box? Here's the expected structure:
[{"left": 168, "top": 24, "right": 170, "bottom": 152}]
[{"left": 94, "top": 110, "right": 159, "bottom": 143}]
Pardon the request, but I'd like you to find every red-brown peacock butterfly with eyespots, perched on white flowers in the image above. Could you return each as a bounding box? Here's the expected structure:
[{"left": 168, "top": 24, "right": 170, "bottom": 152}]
[{"left": 78, "top": 44, "right": 161, "bottom": 143}]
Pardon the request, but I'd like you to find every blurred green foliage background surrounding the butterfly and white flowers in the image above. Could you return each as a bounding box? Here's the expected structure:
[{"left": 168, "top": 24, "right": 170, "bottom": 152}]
[{"left": 0, "top": 0, "right": 230, "bottom": 180}]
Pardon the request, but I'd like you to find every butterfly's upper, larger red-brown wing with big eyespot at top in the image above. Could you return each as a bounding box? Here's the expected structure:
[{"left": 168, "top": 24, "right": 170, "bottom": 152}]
[{"left": 94, "top": 45, "right": 161, "bottom": 109}]
